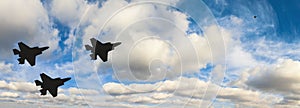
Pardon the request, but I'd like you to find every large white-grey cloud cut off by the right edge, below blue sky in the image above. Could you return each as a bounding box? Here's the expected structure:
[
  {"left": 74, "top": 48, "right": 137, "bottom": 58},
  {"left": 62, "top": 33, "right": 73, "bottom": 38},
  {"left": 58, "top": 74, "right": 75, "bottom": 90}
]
[{"left": 245, "top": 59, "right": 300, "bottom": 93}]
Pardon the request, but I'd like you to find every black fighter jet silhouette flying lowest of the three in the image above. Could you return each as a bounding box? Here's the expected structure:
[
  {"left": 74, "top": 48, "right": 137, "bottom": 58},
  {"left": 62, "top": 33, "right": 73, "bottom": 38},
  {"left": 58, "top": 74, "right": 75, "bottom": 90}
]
[{"left": 34, "top": 73, "right": 71, "bottom": 97}]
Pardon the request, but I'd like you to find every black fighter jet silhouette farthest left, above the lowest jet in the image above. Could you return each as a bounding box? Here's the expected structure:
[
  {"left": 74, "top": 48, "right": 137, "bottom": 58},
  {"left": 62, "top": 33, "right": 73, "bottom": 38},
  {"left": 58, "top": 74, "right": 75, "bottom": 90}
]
[{"left": 13, "top": 42, "right": 49, "bottom": 66}]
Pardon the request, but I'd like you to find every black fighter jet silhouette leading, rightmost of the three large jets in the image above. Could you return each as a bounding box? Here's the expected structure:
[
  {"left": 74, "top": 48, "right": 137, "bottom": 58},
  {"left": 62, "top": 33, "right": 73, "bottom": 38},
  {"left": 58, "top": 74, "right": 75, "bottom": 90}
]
[{"left": 85, "top": 38, "right": 121, "bottom": 62}]
